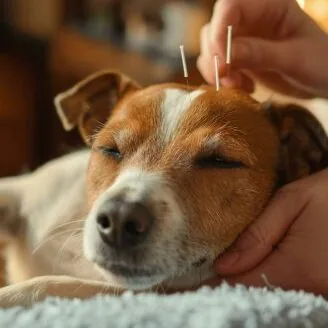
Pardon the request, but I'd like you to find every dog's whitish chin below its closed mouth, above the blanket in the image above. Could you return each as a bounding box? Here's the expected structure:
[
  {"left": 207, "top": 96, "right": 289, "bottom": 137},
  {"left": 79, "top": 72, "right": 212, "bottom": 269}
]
[{"left": 96, "top": 264, "right": 166, "bottom": 290}]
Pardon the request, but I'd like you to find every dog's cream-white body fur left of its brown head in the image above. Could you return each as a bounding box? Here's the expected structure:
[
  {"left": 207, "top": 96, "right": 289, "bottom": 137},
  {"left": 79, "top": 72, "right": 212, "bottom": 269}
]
[{"left": 0, "top": 150, "right": 103, "bottom": 283}]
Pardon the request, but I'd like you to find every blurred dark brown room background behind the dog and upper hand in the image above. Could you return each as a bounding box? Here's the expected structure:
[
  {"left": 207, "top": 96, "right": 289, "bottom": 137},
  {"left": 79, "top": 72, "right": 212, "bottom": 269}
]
[{"left": 0, "top": 0, "right": 328, "bottom": 176}]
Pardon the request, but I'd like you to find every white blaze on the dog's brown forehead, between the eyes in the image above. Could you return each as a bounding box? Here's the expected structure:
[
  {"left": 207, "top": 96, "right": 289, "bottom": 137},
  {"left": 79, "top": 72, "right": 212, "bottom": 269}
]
[{"left": 161, "top": 89, "right": 205, "bottom": 141}]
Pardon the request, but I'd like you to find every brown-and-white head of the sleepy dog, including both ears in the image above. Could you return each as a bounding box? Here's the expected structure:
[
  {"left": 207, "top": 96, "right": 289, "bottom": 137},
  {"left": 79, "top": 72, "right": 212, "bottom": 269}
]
[{"left": 56, "top": 72, "right": 328, "bottom": 289}]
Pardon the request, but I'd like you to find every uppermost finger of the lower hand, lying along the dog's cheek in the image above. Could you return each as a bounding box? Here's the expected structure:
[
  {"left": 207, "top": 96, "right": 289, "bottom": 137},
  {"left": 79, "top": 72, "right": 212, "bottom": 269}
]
[{"left": 214, "top": 183, "right": 310, "bottom": 275}]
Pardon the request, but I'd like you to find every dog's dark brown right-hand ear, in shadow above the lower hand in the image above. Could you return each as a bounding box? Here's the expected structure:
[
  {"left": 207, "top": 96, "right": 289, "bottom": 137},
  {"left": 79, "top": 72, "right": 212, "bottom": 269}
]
[{"left": 265, "top": 104, "right": 328, "bottom": 185}]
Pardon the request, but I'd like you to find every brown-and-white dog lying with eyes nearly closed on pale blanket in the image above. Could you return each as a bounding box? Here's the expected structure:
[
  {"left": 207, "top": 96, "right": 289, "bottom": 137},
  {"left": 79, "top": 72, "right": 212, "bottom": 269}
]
[{"left": 0, "top": 71, "right": 328, "bottom": 307}]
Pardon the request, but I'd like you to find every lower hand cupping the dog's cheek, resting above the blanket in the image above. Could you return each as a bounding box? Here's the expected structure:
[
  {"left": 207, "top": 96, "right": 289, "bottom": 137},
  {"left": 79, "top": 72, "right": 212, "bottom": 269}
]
[{"left": 209, "top": 169, "right": 328, "bottom": 295}]
